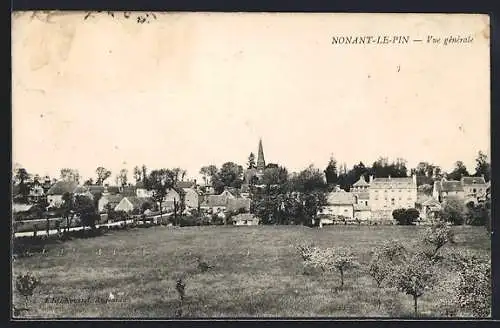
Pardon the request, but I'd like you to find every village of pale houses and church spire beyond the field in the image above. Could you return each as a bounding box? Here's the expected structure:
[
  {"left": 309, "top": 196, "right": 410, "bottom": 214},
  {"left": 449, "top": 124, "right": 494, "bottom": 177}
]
[{"left": 12, "top": 140, "right": 490, "bottom": 232}]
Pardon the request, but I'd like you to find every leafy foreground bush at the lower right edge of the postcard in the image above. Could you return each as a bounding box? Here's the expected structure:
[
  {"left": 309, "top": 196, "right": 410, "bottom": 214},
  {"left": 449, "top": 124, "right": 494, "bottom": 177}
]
[{"left": 456, "top": 252, "right": 491, "bottom": 317}]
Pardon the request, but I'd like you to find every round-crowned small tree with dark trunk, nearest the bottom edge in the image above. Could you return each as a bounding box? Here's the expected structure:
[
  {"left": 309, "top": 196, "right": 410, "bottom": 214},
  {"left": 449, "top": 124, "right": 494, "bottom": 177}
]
[{"left": 392, "top": 254, "right": 436, "bottom": 316}]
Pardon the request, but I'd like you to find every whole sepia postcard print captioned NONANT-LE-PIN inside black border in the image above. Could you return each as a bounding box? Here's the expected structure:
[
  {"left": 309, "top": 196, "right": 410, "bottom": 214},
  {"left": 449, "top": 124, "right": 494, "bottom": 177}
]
[{"left": 10, "top": 11, "right": 492, "bottom": 320}]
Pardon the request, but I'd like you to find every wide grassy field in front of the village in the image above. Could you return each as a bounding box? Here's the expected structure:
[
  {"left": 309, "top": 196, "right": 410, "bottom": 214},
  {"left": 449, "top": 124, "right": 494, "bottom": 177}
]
[{"left": 13, "top": 226, "right": 490, "bottom": 318}]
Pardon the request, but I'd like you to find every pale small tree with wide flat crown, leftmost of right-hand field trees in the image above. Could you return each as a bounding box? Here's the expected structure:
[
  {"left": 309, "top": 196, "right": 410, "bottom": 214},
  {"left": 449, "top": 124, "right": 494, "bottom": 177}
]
[{"left": 309, "top": 248, "right": 358, "bottom": 288}]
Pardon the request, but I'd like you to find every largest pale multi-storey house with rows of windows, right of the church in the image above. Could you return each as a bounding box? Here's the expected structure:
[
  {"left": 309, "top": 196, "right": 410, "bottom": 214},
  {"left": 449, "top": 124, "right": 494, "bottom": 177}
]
[{"left": 368, "top": 175, "right": 417, "bottom": 221}]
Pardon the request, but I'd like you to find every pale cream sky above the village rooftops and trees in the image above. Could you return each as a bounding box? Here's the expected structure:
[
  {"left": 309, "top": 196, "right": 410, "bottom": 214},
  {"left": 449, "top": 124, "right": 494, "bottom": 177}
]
[{"left": 12, "top": 12, "right": 490, "bottom": 179}]
